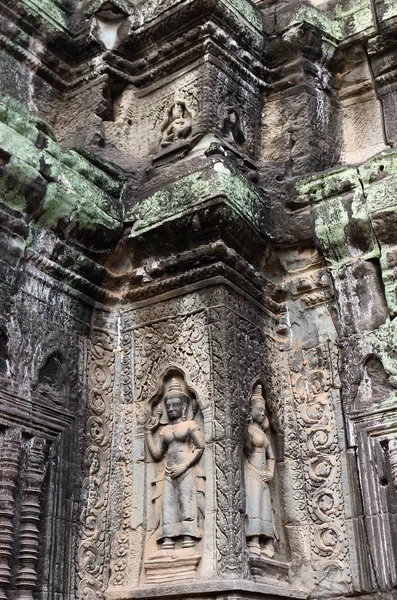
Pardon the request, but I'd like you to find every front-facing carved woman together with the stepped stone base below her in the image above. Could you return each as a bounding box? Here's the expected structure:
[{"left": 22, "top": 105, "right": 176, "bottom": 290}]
[{"left": 144, "top": 372, "right": 205, "bottom": 583}]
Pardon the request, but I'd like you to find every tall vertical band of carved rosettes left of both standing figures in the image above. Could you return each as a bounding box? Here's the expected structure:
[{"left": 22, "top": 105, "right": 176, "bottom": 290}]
[{"left": 77, "top": 332, "right": 115, "bottom": 600}]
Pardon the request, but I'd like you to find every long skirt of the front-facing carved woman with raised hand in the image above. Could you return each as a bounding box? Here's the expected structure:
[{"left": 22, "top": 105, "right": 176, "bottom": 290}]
[{"left": 156, "top": 467, "right": 204, "bottom": 540}]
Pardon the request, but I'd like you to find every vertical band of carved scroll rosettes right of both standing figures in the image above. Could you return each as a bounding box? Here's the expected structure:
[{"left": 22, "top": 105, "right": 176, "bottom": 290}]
[{"left": 290, "top": 345, "right": 351, "bottom": 584}]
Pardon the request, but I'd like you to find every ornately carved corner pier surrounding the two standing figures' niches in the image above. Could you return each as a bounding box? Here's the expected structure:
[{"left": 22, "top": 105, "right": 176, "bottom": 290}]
[{"left": 103, "top": 285, "right": 290, "bottom": 595}]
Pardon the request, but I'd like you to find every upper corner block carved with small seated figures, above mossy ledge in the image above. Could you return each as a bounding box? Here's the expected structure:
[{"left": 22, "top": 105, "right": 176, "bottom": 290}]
[{"left": 103, "top": 63, "right": 261, "bottom": 157}]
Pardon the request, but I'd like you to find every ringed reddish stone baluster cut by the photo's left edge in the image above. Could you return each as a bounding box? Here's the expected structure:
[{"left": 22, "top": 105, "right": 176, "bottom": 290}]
[{"left": 0, "top": 429, "right": 21, "bottom": 600}]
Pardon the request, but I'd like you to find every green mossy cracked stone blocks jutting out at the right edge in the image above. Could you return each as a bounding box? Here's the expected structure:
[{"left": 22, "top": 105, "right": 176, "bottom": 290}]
[{"left": 295, "top": 150, "right": 397, "bottom": 317}]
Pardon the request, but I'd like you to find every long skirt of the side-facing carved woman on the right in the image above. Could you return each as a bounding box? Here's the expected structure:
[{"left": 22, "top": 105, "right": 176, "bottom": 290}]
[{"left": 245, "top": 462, "right": 274, "bottom": 538}]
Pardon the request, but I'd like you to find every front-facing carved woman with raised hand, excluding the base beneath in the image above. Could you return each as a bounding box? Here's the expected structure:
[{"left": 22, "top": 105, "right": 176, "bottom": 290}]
[{"left": 146, "top": 377, "right": 204, "bottom": 550}]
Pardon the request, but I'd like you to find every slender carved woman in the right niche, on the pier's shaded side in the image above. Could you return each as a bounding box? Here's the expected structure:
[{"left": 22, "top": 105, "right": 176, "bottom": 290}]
[{"left": 245, "top": 385, "right": 275, "bottom": 558}]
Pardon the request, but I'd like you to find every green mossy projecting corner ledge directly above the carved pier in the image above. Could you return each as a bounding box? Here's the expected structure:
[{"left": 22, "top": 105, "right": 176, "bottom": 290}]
[{"left": 126, "top": 156, "right": 267, "bottom": 260}]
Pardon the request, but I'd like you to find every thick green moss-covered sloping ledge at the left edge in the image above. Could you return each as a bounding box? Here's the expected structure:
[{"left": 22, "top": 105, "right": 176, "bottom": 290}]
[{"left": 0, "top": 96, "right": 124, "bottom": 251}]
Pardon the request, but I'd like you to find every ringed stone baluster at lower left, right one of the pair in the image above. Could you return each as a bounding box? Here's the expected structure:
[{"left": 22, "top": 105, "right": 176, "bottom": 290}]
[{"left": 16, "top": 437, "right": 46, "bottom": 600}]
